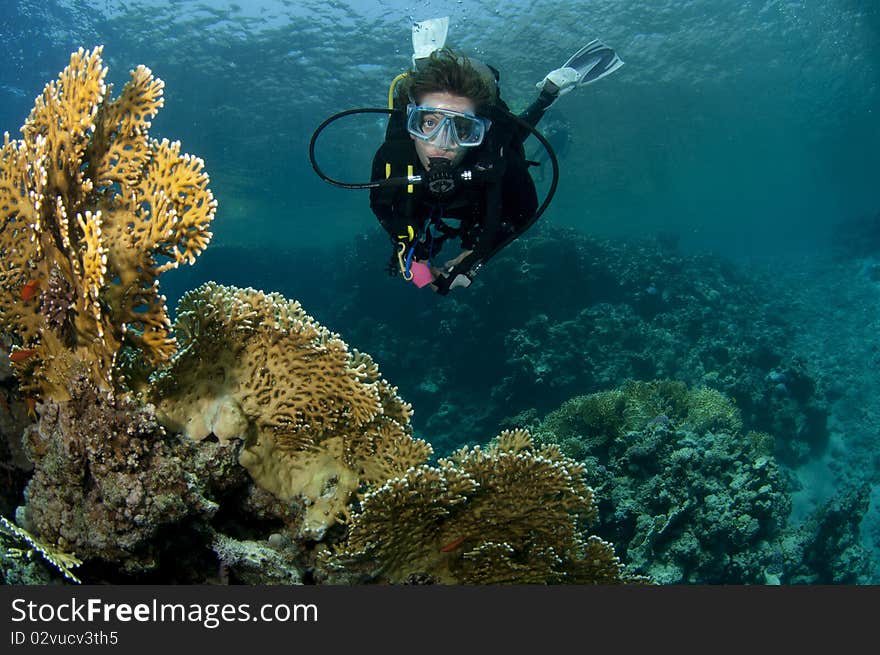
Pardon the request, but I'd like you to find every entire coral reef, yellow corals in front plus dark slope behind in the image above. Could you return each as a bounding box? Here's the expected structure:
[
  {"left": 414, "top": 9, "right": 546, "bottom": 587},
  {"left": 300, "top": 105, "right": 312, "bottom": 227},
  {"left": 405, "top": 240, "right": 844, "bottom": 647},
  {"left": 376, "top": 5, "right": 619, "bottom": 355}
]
[{"left": 0, "top": 48, "right": 869, "bottom": 584}]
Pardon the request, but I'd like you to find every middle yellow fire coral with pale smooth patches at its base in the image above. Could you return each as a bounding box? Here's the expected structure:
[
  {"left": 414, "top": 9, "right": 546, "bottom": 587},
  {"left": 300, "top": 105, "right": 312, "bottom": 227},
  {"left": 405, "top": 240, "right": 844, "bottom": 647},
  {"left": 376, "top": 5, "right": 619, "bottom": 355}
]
[{"left": 152, "top": 283, "right": 431, "bottom": 538}]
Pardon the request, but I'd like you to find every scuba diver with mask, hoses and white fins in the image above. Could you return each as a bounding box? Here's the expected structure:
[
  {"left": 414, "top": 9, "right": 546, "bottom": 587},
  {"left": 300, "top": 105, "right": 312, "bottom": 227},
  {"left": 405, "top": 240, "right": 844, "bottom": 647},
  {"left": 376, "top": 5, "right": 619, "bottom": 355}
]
[{"left": 310, "top": 18, "right": 623, "bottom": 295}]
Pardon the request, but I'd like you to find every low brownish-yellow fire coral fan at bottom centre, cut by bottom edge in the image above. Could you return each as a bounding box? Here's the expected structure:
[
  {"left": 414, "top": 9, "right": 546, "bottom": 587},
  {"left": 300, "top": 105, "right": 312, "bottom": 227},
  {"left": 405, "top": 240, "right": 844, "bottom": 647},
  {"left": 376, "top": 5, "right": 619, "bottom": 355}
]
[{"left": 338, "top": 430, "right": 628, "bottom": 584}]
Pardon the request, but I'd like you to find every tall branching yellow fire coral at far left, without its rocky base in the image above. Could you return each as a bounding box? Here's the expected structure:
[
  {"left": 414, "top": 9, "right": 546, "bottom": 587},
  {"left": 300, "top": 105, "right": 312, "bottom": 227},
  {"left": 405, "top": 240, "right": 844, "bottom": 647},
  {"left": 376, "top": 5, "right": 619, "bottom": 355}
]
[{"left": 0, "top": 46, "right": 216, "bottom": 400}]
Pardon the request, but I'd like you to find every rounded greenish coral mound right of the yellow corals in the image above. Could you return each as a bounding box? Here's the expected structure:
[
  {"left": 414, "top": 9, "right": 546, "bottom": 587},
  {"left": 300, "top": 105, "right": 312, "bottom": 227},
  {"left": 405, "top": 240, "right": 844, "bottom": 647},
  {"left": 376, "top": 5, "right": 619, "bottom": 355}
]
[{"left": 536, "top": 380, "right": 791, "bottom": 584}]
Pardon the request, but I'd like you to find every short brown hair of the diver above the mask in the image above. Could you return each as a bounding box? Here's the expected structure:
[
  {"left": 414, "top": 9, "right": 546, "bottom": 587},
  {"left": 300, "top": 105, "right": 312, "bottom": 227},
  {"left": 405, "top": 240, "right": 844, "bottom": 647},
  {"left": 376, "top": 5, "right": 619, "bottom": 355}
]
[{"left": 399, "top": 48, "right": 498, "bottom": 112}]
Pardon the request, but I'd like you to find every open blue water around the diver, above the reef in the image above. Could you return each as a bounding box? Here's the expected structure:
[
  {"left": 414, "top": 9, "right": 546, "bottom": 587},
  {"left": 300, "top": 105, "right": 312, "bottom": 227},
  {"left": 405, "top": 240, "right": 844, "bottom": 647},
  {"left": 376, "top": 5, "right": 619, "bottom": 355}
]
[{"left": 0, "top": 0, "right": 880, "bottom": 584}]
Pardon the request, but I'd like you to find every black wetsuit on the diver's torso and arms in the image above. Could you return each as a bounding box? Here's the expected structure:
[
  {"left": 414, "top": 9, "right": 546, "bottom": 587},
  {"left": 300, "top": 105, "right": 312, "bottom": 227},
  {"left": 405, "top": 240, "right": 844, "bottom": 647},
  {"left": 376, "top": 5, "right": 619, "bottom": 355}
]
[{"left": 370, "top": 89, "right": 554, "bottom": 288}]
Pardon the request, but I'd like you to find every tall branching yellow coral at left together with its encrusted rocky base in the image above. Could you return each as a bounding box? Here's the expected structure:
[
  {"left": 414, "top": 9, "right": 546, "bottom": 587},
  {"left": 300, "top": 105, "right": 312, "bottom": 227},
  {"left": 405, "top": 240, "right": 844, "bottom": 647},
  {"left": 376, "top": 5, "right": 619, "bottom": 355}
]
[{"left": 0, "top": 47, "right": 216, "bottom": 571}]
